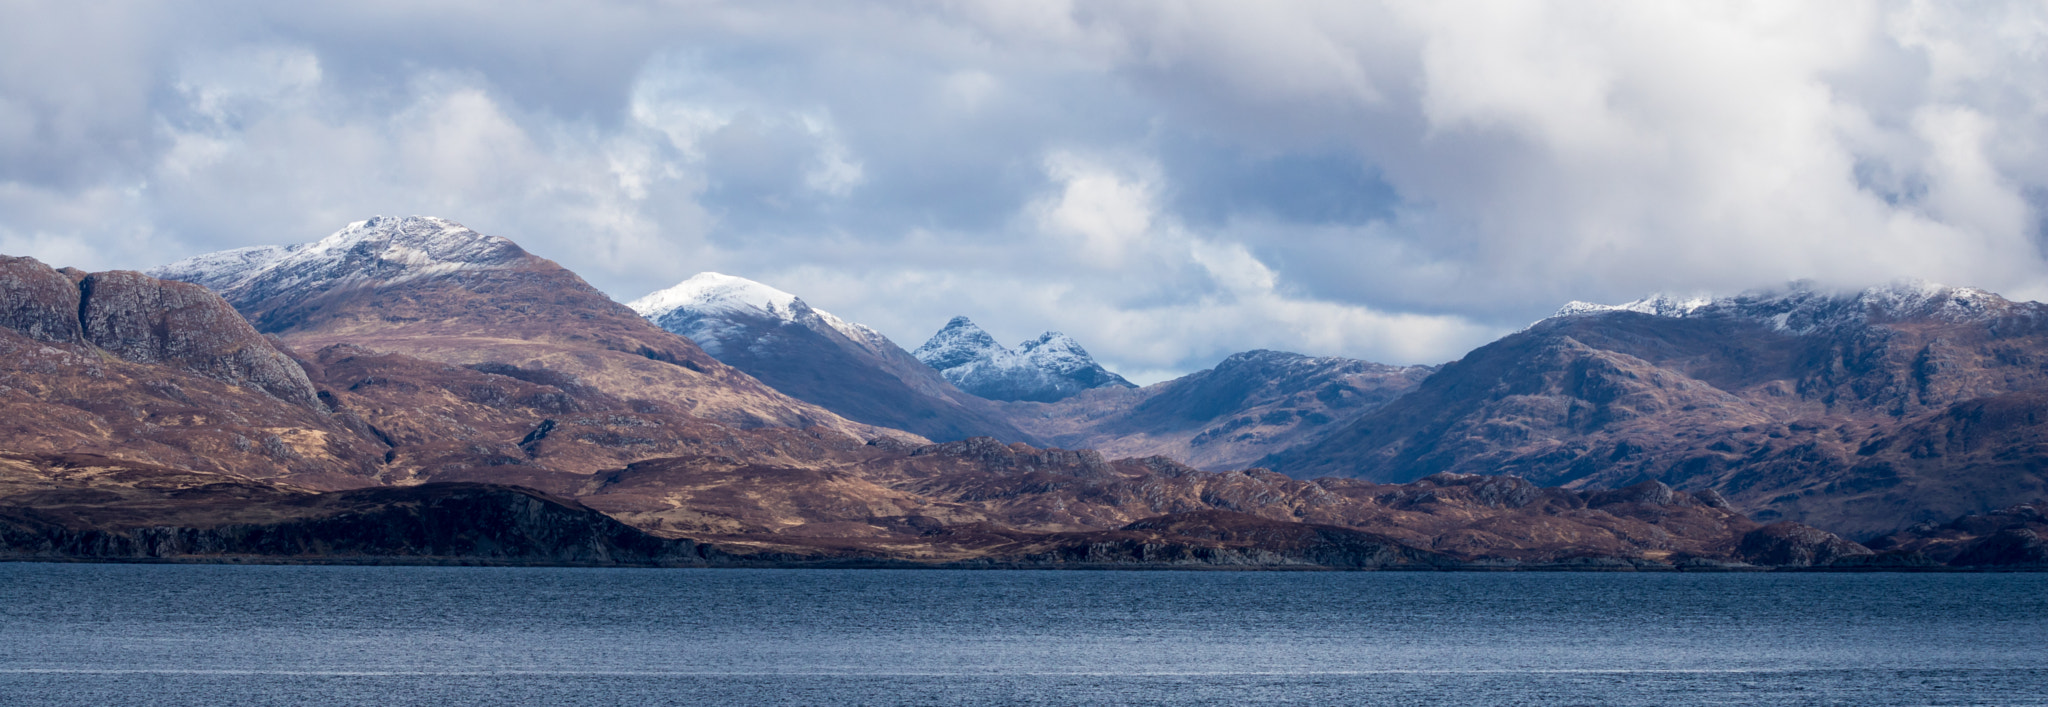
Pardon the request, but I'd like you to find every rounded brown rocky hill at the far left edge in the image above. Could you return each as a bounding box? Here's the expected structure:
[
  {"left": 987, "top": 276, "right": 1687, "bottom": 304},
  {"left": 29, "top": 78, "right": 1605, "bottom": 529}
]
[{"left": 0, "top": 258, "right": 383, "bottom": 488}]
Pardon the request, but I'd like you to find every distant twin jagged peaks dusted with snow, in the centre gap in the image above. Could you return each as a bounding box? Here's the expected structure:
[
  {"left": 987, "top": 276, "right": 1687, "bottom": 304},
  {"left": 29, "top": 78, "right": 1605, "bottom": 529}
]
[{"left": 911, "top": 318, "right": 1137, "bottom": 402}]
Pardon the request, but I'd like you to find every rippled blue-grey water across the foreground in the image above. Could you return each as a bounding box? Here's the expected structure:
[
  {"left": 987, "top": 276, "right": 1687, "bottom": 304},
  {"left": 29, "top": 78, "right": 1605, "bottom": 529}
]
[{"left": 0, "top": 564, "right": 2048, "bottom": 705}]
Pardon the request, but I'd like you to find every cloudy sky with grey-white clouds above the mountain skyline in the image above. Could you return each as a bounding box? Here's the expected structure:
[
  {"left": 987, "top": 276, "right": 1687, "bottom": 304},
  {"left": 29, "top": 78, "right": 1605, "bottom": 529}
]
[{"left": 0, "top": 0, "right": 2048, "bottom": 383}]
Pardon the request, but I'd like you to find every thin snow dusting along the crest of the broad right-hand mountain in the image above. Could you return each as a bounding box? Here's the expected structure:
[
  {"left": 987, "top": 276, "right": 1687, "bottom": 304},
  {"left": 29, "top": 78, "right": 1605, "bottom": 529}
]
[{"left": 1552, "top": 281, "right": 2048, "bottom": 334}]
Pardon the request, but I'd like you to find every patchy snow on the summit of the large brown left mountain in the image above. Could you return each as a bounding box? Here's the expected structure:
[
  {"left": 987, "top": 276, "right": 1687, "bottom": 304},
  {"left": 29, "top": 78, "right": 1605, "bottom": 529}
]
[{"left": 145, "top": 215, "right": 526, "bottom": 301}]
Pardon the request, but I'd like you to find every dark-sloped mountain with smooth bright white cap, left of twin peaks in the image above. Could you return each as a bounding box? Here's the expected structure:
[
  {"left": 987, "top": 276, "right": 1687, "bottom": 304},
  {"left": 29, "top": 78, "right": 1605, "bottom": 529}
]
[{"left": 627, "top": 273, "right": 1036, "bottom": 443}]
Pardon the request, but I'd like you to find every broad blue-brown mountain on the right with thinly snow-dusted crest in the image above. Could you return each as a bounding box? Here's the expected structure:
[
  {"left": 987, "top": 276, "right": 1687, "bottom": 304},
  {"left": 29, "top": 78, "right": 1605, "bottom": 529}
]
[{"left": 1266, "top": 283, "right": 2048, "bottom": 535}]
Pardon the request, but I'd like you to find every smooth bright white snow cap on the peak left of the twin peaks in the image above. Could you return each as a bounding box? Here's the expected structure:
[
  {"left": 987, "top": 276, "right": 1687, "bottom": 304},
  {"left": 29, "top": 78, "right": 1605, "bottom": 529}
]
[{"left": 627, "top": 273, "right": 895, "bottom": 355}]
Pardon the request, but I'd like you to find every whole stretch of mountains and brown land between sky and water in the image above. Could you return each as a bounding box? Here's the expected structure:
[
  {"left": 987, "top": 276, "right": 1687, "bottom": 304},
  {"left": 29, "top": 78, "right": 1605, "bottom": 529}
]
[{"left": 0, "top": 217, "right": 2048, "bottom": 570}]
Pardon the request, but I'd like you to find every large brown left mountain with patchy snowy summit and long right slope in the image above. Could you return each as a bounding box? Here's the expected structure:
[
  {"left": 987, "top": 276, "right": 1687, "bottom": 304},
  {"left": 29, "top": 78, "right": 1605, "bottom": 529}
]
[{"left": 150, "top": 217, "right": 891, "bottom": 436}]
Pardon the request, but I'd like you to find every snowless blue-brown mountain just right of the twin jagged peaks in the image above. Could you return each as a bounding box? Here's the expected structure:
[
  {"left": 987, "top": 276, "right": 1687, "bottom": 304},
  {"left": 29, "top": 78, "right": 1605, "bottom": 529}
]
[{"left": 1006, "top": 350, "right": 1434, "bottom": 469}]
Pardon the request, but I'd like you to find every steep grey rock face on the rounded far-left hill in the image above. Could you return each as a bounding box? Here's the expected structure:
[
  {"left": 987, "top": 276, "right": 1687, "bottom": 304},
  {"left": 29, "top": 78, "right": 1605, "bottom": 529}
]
[{"left": 78, "top": 271, "right": 319, "bottom": 406}]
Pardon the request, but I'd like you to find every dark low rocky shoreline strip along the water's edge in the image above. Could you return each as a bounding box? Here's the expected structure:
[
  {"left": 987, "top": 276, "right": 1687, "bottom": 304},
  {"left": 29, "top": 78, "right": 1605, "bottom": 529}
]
[{"left": 12, "top": 475, "right": 2048, "bottom": 572}]
